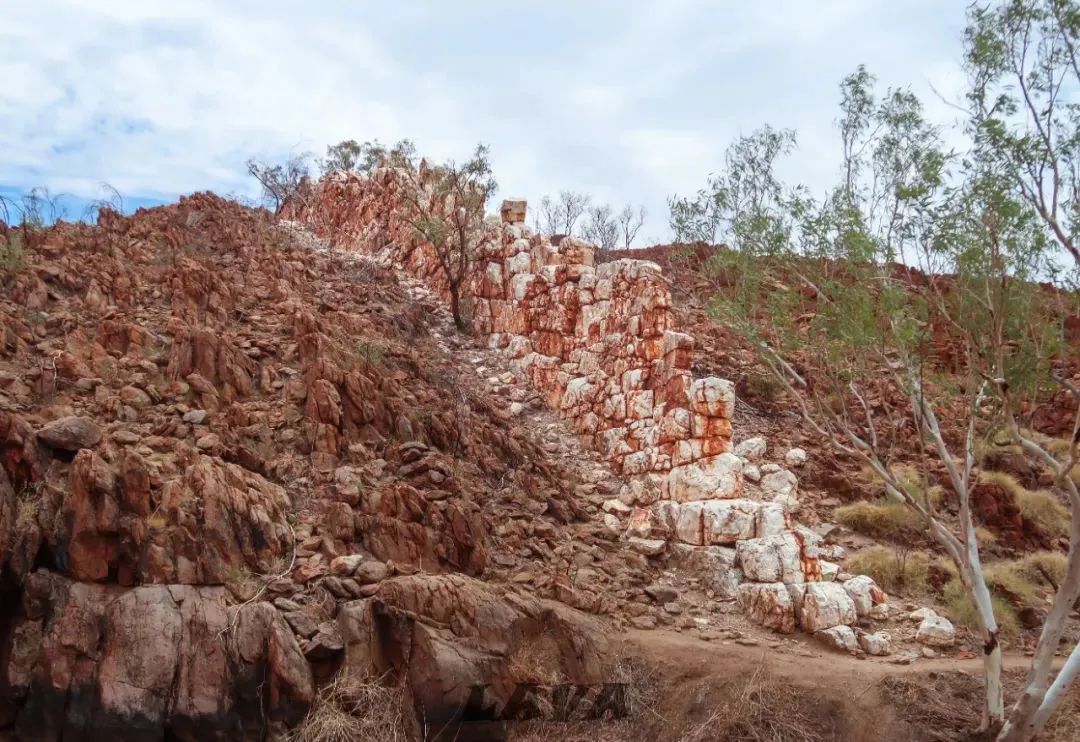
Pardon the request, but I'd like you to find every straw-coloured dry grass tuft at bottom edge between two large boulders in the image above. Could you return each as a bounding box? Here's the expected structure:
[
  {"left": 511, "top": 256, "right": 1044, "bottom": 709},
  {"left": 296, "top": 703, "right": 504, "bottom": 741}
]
[{"left": 288, "top": 673, "right": 407, "bottom": 742}]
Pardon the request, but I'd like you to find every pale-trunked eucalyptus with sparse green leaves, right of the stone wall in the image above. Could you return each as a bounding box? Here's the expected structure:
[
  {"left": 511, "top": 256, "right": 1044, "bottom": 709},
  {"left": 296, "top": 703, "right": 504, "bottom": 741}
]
[{"left": 671, "top": 62, "right": 1080, "bottom": 740}]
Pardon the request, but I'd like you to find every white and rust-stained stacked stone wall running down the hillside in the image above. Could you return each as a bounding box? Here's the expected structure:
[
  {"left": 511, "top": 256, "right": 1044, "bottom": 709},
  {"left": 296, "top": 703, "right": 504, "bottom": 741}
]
[{"left": 295, "top": 182, "right": 888, "bottom": 653}]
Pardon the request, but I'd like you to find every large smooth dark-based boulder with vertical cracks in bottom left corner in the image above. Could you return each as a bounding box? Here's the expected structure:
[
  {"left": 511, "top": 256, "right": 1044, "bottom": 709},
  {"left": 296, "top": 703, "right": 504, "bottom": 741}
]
[{"left": 0, "top": 571, "right": 314, "bottom": 741}]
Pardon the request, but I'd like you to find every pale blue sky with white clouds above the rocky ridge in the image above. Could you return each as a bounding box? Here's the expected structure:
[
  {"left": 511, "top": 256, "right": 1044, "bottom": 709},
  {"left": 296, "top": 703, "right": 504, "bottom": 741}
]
[{"left": 0, "top": 0, "right": 967, "bottom": 244}]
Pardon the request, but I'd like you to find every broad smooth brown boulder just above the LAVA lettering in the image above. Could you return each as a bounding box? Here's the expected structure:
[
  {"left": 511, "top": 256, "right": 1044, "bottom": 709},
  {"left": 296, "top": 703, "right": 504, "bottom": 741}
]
[{"left": 338, "top": 575, "right": 607, "bottom": 739}]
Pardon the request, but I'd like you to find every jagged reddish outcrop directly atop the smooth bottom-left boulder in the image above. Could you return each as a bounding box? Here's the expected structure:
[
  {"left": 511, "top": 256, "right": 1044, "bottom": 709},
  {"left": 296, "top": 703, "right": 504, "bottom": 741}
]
[{"left": 58, "top": 449, "right": 293, "bottom": 585}]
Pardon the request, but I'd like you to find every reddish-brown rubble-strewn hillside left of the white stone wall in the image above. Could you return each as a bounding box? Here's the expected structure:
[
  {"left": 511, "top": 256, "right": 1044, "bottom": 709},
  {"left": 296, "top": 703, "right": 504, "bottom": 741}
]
[{"left": 0, "top": 194, "right": 649, "bottom": 739}]
